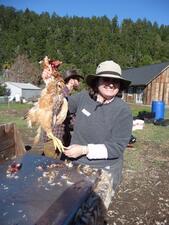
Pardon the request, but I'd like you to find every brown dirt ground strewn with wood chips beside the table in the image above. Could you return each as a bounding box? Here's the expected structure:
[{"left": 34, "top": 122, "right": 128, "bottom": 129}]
[{"left": 3, "top": 108, "right": 169, "bottom": 225}]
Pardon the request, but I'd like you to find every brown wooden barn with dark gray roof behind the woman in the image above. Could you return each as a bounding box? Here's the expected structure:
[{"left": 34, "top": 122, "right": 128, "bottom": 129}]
[{"left": 123, "top": 62, "right": 169, "bottom": 105}]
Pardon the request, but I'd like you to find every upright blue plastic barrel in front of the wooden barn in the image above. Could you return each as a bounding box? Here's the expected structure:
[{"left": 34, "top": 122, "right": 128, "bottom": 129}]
[{"left": 151, "top": 101, "right": 165, "bottom": 120}]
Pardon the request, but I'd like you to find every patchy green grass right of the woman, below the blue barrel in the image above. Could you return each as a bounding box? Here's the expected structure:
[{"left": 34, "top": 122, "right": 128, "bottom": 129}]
[{"left": 124, "top": 104, "right": 169, "bottom": 172}]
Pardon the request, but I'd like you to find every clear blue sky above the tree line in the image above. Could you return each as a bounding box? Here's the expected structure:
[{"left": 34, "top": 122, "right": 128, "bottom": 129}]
[{"left": 0, "top": 0, "right": 169, "bottom": 25}]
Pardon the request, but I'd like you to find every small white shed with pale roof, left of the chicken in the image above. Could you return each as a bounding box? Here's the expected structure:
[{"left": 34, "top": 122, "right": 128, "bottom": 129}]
[{"left": 5, "top": 82, "right": 41, "bottom": 101}]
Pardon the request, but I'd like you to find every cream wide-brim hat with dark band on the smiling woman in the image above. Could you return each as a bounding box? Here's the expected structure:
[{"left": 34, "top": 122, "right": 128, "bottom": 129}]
[{"left": 86, "top": 60, "right": 131, "bottom": 90}]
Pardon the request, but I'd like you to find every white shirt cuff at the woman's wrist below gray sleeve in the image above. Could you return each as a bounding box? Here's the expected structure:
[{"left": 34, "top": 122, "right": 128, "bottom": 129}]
[{"left": 86, "top": 144, "right": 108, "bottom": 159}]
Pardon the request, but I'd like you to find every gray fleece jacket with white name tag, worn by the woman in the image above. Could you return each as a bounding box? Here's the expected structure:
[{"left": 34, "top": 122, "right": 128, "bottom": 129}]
[{"left": 68, "top": 91, "right": 133, "bottom": 168}]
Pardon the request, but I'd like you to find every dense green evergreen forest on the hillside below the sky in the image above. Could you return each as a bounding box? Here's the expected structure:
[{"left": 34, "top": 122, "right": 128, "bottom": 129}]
[{"left": 0, "top": 5, "right": 169, "bottom": 84}]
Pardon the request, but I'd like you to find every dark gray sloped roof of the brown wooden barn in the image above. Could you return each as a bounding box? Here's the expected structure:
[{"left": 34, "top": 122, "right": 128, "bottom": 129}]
[{"left": 122, "top": 62, "right": 169, "bottom": 85}]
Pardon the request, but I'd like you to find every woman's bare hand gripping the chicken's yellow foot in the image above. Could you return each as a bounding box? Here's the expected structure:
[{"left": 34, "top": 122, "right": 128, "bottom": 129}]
[{"left": 64, "top": 145, "right": 88, "bottom": 158}]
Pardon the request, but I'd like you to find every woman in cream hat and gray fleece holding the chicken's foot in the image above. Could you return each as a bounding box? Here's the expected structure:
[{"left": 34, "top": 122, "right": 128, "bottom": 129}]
[{"left": 64, "top": 60, "right": 133, "bottom": 190}]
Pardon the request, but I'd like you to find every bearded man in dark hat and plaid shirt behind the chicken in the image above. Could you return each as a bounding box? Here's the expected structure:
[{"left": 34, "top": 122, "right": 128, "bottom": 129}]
[{"left": 42, "top": 69, "right": 83, "bottom": 158}]
